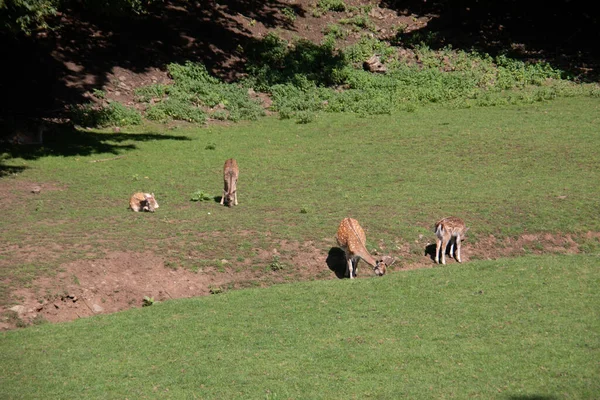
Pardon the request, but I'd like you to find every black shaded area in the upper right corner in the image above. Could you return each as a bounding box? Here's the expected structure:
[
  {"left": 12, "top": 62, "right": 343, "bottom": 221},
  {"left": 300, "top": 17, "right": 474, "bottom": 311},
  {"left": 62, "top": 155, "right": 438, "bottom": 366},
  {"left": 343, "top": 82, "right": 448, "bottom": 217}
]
[{"left": 380, "top": 0, "right": 600, "bottom": 81}]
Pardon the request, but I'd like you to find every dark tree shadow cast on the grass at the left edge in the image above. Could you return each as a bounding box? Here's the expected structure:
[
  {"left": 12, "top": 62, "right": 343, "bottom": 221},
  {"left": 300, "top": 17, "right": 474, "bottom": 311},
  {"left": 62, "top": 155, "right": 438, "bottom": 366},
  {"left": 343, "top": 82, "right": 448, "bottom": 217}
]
[{"left": 0, "top": 123, "right": 191, "bottom": 162}]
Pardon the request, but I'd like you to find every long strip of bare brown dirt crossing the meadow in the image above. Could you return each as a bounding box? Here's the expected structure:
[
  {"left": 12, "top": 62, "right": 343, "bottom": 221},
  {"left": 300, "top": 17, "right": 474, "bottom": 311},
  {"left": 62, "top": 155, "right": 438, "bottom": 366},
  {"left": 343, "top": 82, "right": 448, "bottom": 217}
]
[{"left": 0, "top": 232, "right": 600, "bottom": 329}]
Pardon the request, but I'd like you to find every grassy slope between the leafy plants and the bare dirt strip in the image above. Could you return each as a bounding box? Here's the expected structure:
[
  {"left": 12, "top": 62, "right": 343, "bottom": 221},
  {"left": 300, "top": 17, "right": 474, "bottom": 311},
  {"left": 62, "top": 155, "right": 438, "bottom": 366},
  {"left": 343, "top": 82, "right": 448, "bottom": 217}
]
[{"left": 0, "top": 99, "right": 600, "bottom": 268}]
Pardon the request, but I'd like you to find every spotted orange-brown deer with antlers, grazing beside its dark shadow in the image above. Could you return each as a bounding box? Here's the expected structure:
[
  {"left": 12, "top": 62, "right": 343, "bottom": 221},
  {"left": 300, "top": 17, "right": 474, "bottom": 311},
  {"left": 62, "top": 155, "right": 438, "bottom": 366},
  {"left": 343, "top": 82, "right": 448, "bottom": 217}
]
[{"left": 335, "top": 218, "right": 394, "bottom": 279}]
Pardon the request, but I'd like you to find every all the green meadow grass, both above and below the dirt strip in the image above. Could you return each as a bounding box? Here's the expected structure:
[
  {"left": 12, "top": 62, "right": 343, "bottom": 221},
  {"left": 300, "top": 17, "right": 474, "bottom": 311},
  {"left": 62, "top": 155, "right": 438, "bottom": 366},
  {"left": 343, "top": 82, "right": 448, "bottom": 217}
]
[{"left": 0, "top": 97, "right": 600, "bottom": 399}]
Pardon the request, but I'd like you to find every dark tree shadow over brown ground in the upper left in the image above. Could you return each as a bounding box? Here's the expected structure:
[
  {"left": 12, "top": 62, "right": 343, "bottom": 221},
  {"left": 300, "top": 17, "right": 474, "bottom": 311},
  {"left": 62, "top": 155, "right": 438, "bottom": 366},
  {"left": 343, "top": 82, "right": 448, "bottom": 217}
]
[{"left": 0, "top": 0, "right": 305, "bottom": 122}]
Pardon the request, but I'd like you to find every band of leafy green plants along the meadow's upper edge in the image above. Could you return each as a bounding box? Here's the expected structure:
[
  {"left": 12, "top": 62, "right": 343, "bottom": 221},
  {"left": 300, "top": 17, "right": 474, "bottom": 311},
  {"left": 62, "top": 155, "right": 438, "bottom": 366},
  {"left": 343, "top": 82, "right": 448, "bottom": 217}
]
[{"left": 109, "top": 32, "right": 600, "bottom": 123}]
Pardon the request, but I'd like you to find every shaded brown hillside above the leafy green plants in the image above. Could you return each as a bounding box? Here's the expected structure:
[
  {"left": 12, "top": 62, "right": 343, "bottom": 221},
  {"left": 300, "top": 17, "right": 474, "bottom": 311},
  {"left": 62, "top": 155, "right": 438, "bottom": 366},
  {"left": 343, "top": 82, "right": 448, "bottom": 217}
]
[{"left": 0, "top": 0, "right": 599, "bottom": 122}]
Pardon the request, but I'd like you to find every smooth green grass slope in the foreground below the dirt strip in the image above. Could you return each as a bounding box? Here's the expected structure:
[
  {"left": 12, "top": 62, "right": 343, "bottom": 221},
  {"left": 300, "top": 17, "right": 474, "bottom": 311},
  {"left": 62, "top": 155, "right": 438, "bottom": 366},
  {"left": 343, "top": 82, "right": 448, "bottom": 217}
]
[{"left": 0, "top": 255, "right": 600, "bottom": 399}]
